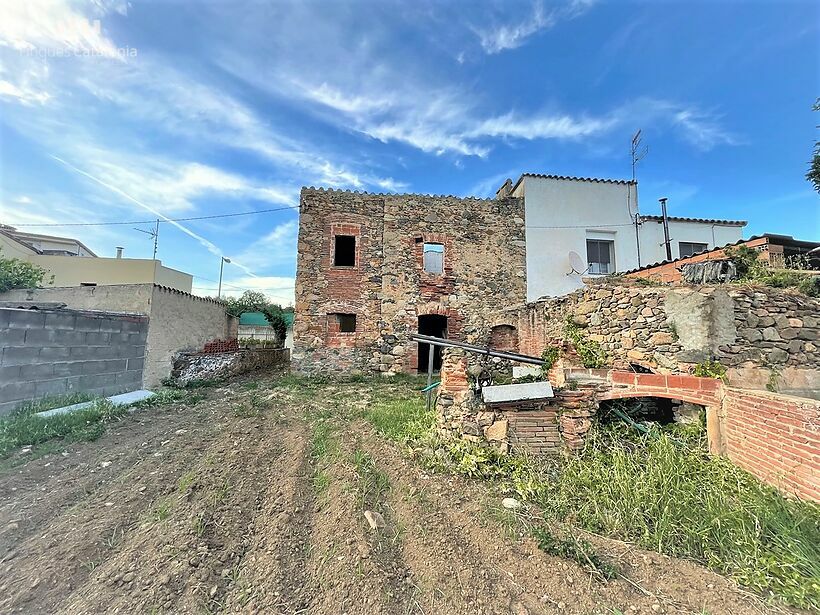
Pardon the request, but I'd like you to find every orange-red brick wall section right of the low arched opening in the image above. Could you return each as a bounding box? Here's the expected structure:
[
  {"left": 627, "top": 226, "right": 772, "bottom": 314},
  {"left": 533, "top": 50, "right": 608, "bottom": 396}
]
[{"left": 723, "top": 388, "right": 820, "bottom": 501}]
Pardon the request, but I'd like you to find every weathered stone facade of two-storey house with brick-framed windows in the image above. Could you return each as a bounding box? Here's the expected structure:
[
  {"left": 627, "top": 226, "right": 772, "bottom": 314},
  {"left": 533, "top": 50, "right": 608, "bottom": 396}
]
[{"left": 293, "top": 188, "right": 526, "bottom": 373}]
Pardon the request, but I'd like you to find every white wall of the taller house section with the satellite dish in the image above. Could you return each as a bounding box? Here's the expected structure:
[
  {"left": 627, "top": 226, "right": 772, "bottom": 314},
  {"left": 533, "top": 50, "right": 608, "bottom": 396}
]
[{"left": 513, "top": 176, "right": 638, "bottom": 301}]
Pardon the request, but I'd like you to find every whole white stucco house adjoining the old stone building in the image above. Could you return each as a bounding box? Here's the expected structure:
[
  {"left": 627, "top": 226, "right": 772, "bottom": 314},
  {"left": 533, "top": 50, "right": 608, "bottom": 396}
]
[{"left": 498, "top": 173, "right": 746, "bottom": 301}]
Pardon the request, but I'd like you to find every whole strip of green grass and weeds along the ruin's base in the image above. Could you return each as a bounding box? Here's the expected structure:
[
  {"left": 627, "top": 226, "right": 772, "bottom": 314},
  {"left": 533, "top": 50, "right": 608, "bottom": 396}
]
[{"left": 365, "top": 388, "right": 820, "bottom": 609}]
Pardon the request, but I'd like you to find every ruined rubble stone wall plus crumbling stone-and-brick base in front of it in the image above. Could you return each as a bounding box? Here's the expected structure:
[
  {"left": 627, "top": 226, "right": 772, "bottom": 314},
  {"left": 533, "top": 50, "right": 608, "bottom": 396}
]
[{"left": 437, "top": 283, "right": 820, "bottom": 453}]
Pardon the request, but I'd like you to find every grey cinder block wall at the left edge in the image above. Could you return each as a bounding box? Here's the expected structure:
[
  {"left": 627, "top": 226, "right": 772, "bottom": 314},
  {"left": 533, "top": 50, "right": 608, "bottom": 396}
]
[{"left": 0, "top": 308, "right": 148, "bottom": 414}]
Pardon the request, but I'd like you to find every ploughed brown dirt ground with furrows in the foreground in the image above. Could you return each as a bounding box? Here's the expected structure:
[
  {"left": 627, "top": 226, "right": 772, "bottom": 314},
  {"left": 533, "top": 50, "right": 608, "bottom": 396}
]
[{"left": 0, "top": 374, "right": 796, "bottom": 615}]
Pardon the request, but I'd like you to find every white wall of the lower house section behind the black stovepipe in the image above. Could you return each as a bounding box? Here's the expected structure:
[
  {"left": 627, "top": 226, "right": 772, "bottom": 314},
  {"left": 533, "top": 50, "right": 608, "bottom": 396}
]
[{"left": 640, "top": 220, "right": 743, "bottom": 266}]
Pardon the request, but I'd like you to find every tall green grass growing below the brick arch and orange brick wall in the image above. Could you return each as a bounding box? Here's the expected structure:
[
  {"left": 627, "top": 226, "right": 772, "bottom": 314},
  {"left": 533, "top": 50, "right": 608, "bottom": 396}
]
[{"left": 538, "top": 427, "right": 820, "bottom": 608}]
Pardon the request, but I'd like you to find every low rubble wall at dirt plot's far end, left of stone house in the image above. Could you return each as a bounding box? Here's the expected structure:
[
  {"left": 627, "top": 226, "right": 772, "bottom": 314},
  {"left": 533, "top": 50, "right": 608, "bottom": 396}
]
[{"left": 171, "top": 348, "right": 290, "bottom": 384}]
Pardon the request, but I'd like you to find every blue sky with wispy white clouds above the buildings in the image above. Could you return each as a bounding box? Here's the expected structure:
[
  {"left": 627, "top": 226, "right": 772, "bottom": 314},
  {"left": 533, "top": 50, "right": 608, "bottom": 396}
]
[{"left": 0, "top": 0, "right": 820, "bottom": 303}]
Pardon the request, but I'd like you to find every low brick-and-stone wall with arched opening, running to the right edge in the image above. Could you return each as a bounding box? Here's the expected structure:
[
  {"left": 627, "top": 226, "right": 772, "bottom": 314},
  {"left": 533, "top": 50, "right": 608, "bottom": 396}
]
[{"left": 437, "top": 350, "right": 820, "bottom": 501}]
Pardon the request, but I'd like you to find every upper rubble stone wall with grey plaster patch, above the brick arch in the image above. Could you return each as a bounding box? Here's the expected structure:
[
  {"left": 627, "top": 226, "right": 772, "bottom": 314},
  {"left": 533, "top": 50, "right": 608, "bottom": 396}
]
[{"left": 502, "top": 282, "right": 820, "bottom": 397}]
